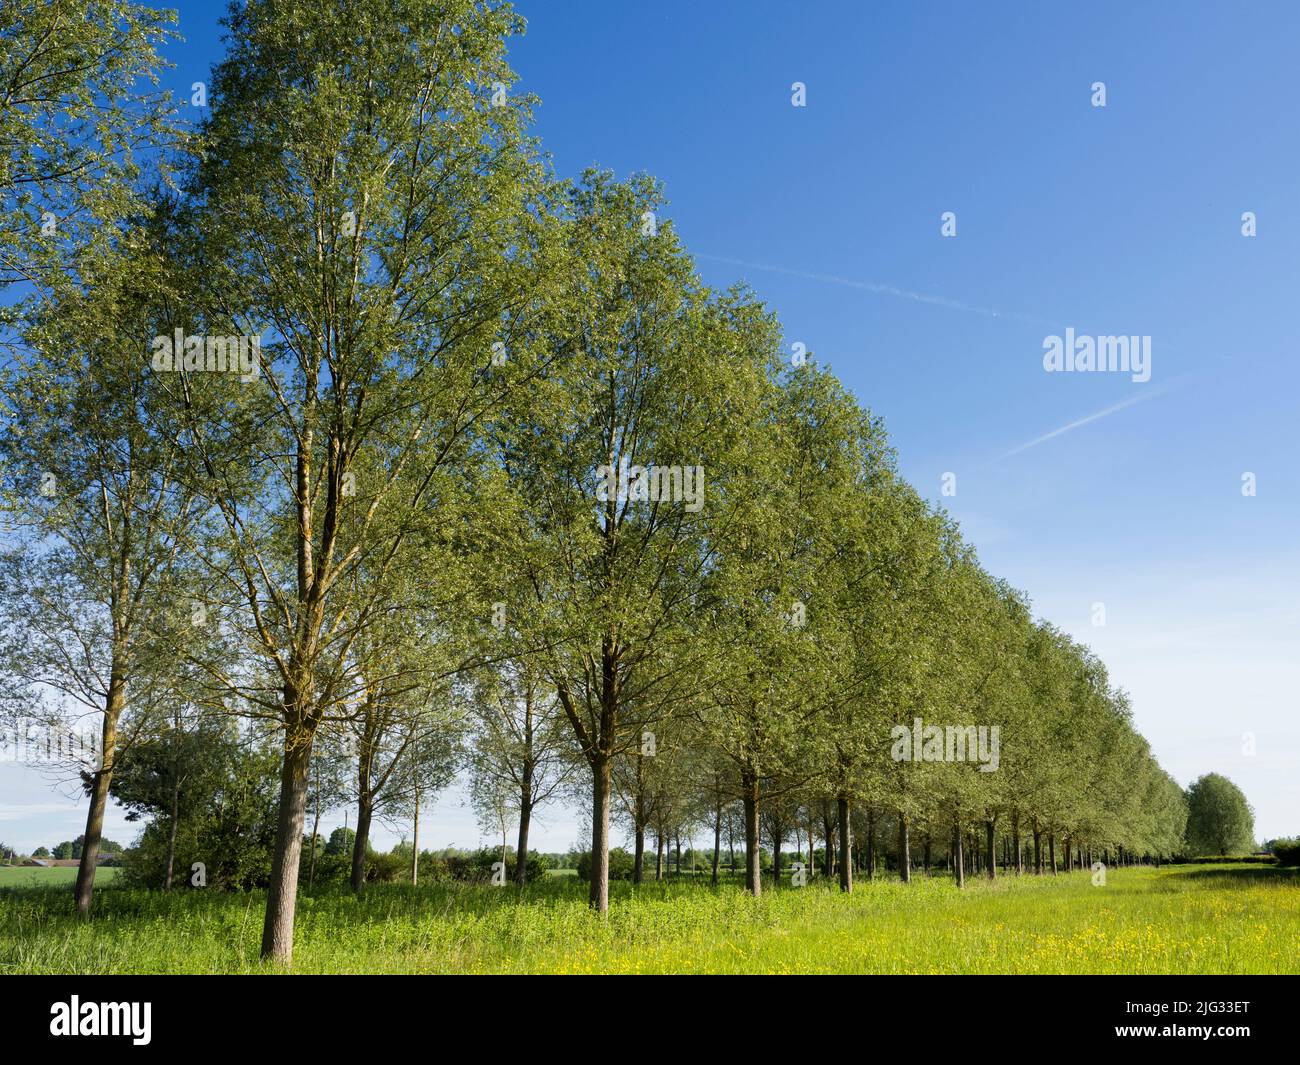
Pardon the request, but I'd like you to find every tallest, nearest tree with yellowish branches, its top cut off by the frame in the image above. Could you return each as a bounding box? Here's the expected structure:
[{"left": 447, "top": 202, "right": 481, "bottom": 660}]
[{"left": 180, "top": 0, "right": 545, "bottom": 962}]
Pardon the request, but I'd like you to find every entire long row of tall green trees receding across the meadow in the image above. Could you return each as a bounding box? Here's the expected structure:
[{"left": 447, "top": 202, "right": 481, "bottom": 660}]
[{"left": 0, "top": 0, "right": 1186, "bottom": 961}]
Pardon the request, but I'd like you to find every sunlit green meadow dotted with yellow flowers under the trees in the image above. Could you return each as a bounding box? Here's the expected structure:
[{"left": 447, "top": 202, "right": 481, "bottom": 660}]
[{"left": 0, "top": 865, "right": 1300, "bottom": 973}]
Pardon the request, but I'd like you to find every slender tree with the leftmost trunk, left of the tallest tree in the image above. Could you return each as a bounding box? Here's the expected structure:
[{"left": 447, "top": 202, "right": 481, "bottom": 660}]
[{"left": 0, "top": 215, "right": 204, "bottom": 915}]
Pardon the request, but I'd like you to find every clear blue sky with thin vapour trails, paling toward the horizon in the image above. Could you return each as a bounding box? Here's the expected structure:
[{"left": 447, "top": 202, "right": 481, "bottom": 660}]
[{"left": 0, "top": 0, "right": 1300, "bottom": 849}]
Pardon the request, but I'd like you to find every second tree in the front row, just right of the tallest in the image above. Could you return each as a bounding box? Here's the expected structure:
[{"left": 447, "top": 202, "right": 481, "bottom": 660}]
[{"left": 488, "top": 173, "right": 763, "bottom": 912}]
